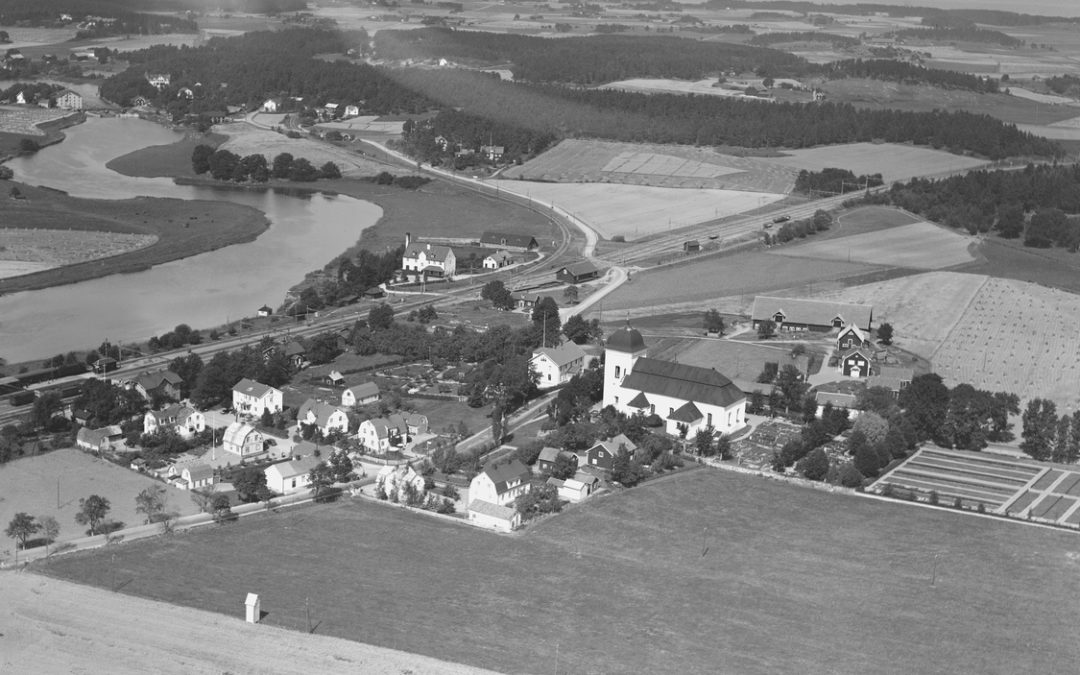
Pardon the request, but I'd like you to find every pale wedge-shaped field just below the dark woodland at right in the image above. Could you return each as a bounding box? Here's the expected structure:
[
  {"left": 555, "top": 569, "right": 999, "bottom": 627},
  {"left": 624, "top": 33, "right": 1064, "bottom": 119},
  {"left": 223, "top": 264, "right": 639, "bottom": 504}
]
[{"left": 773, "top": 222, "right": 978, "bottom": 270}]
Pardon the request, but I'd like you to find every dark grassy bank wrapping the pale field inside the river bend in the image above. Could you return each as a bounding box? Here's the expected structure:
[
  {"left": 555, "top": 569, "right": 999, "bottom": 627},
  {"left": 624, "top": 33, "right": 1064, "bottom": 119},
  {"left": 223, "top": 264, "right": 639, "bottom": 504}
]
[{"left": 0, "top": 181, "right": 270, "bottom": 293}]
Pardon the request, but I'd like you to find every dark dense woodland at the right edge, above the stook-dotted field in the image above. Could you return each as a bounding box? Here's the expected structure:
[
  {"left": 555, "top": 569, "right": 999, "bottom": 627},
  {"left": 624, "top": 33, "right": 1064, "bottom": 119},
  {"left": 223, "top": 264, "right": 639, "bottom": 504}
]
[{"left": 864, "top": 164, "right": 1080, "bottom": 251}]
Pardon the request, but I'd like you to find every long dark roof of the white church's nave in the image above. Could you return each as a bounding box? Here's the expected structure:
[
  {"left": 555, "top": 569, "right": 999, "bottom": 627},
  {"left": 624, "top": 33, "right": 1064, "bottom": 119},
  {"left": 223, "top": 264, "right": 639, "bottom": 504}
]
[{"left": 622, "top": 356, "right": 746, "bottom": 407}]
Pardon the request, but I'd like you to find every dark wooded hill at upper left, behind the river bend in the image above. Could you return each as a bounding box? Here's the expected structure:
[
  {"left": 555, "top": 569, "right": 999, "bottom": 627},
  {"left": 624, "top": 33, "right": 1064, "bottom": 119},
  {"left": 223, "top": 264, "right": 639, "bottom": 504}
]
[{"left": 100, "top": 28, "right": 433, "bottom": 116}]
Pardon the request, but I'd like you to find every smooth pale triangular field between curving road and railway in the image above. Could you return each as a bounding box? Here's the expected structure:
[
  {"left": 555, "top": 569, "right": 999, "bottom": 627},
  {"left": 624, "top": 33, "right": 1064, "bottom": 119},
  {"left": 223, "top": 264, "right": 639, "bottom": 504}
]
[{"left": 487, "top": 180, "right": 784, "bottom": 241}]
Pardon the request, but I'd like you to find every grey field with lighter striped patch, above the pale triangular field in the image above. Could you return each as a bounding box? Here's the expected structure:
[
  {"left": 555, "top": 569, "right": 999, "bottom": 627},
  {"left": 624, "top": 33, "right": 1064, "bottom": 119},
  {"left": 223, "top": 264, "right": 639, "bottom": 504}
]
[{"left": 502, "top": 138, "right": 798, "bottom": 192}]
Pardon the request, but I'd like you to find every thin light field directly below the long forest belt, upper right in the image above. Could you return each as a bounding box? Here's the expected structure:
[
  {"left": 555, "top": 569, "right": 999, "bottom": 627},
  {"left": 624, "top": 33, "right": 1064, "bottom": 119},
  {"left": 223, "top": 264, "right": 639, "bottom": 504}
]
[{"left": 760, "top": 143, "right": 988, "bottom": 184}]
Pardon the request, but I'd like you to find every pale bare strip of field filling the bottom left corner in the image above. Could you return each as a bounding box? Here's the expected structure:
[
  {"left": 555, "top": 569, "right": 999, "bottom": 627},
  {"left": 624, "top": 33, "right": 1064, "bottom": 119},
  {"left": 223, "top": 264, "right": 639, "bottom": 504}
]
[{"left": 0, "top": 571, "right": 501, "bottom": 675}]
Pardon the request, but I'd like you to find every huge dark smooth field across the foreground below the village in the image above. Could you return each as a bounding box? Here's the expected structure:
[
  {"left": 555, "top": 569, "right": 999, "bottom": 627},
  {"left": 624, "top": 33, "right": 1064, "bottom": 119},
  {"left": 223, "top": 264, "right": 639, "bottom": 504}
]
[{"left": 42, "top": 470, "right": 1080, "bottom": 675}]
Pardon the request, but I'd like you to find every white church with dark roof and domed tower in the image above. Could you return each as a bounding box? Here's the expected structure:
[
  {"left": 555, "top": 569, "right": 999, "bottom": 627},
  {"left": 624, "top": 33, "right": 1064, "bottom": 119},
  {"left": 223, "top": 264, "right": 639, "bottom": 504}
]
[{"left": 604, "top": 324, "right": 746, "bottom": 438}]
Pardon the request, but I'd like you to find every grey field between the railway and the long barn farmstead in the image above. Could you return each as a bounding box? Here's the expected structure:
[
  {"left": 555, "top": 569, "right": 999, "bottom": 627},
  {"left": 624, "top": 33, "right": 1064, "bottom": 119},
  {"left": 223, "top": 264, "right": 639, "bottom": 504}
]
[{"left": 604, "top": 253, "right": 876, "bottom": 315}]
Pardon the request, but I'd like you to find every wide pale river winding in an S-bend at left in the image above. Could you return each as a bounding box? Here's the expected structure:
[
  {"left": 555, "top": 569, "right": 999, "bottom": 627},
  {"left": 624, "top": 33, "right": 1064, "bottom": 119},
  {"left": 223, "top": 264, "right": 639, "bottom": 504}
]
[{"left": 0, "top": 118, "right": 382, "bottom": 362}]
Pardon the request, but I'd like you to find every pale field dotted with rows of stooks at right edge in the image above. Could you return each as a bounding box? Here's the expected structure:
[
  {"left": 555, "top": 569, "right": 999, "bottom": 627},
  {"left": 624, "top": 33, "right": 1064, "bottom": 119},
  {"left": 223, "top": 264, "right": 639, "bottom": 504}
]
[{"left": 933, "top": 279, "right": 1080, "bottom": 413}]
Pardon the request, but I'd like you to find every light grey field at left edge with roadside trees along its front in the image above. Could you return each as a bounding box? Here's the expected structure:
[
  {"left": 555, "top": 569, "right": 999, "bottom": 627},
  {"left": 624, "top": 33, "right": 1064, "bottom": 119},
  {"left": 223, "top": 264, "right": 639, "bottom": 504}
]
[{"left": 0, "top": 448, "right": 199, "bottom": 557}]
